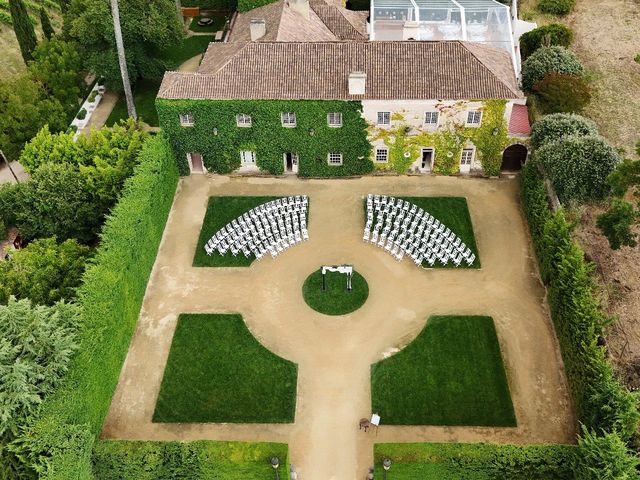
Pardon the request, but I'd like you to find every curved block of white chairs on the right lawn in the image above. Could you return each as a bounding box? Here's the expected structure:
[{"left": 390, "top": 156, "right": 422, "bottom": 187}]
[{"left": 362, "top": 194, "right": 476, "bottom": 267}]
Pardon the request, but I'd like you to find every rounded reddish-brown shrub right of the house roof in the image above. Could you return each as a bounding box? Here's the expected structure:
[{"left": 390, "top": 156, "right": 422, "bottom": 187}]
[{"left": 533, "top": 72, "right": 591, "bottom": 113}]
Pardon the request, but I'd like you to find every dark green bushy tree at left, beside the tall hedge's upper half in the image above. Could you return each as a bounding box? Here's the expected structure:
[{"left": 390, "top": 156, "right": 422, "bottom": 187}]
[{"left": 0, "top": 163, "right": 107, "bottom": 243}]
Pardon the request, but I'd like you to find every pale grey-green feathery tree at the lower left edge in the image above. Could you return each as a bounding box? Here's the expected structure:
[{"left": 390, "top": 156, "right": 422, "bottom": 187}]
[{"left": 0, "top": 297, "right": 80, "bottom": 439}]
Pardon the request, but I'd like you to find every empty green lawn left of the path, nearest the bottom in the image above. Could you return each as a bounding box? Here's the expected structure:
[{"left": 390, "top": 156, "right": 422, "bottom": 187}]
[{"left": 153, "top": 314, "right": 298, "bottom": 423}]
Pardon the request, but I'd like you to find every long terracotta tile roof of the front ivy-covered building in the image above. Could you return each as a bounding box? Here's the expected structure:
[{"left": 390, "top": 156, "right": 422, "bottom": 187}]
[{"left": 159, "top": 41, "right": 523, "bottom": 100}]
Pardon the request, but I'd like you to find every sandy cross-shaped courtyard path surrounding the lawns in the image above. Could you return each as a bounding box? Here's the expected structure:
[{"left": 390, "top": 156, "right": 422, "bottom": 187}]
[{"left": 102, "top": 175, "right": 575, "bottom": 480}]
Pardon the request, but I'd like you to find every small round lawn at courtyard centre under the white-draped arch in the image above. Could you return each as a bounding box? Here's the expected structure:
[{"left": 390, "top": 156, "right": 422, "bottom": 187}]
[{"left": 302, "top": 269, "right": 369, "bottom": 315}]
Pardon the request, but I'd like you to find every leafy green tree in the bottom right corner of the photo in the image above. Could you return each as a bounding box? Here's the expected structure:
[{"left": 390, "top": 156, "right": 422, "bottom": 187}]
[{"left": 574, "top": 428, "right": 639, "bottom": 480}]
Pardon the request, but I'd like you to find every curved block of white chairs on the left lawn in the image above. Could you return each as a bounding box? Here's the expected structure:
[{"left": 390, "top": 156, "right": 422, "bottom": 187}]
[{"left": 204, "top": 195, "right": 309, "bottom": 260}]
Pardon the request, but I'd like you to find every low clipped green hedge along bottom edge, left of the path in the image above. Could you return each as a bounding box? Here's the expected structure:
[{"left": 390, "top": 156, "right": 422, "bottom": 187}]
[{"left": 93, "top": 440, "right": 289, "bottom": 480}]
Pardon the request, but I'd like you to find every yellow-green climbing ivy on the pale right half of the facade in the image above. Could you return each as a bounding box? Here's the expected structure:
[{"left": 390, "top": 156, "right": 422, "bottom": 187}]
[{"left": 369, "top": 100, "right": 509, "bottom": 176}]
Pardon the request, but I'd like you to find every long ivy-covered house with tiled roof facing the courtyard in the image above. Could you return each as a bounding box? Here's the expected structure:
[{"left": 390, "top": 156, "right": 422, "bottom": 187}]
[{"left": 156, "top": 39, "right": 529, "bottom": 177}]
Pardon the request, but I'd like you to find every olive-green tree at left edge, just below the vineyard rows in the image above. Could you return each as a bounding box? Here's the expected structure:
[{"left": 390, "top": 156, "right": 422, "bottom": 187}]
[{"left": 0, "top": 75, "right": 68, "bottom": 160}]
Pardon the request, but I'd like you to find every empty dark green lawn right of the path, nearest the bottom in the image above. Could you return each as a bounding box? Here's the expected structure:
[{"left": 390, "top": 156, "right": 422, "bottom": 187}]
[{"left": 371, "top": 316, "right": 516, "bottom": 427}]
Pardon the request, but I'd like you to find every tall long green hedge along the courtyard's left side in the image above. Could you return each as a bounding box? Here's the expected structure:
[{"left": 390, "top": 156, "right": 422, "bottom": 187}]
[{"left": 14, "top": 136, "right": 178, "bottom": 480}]
